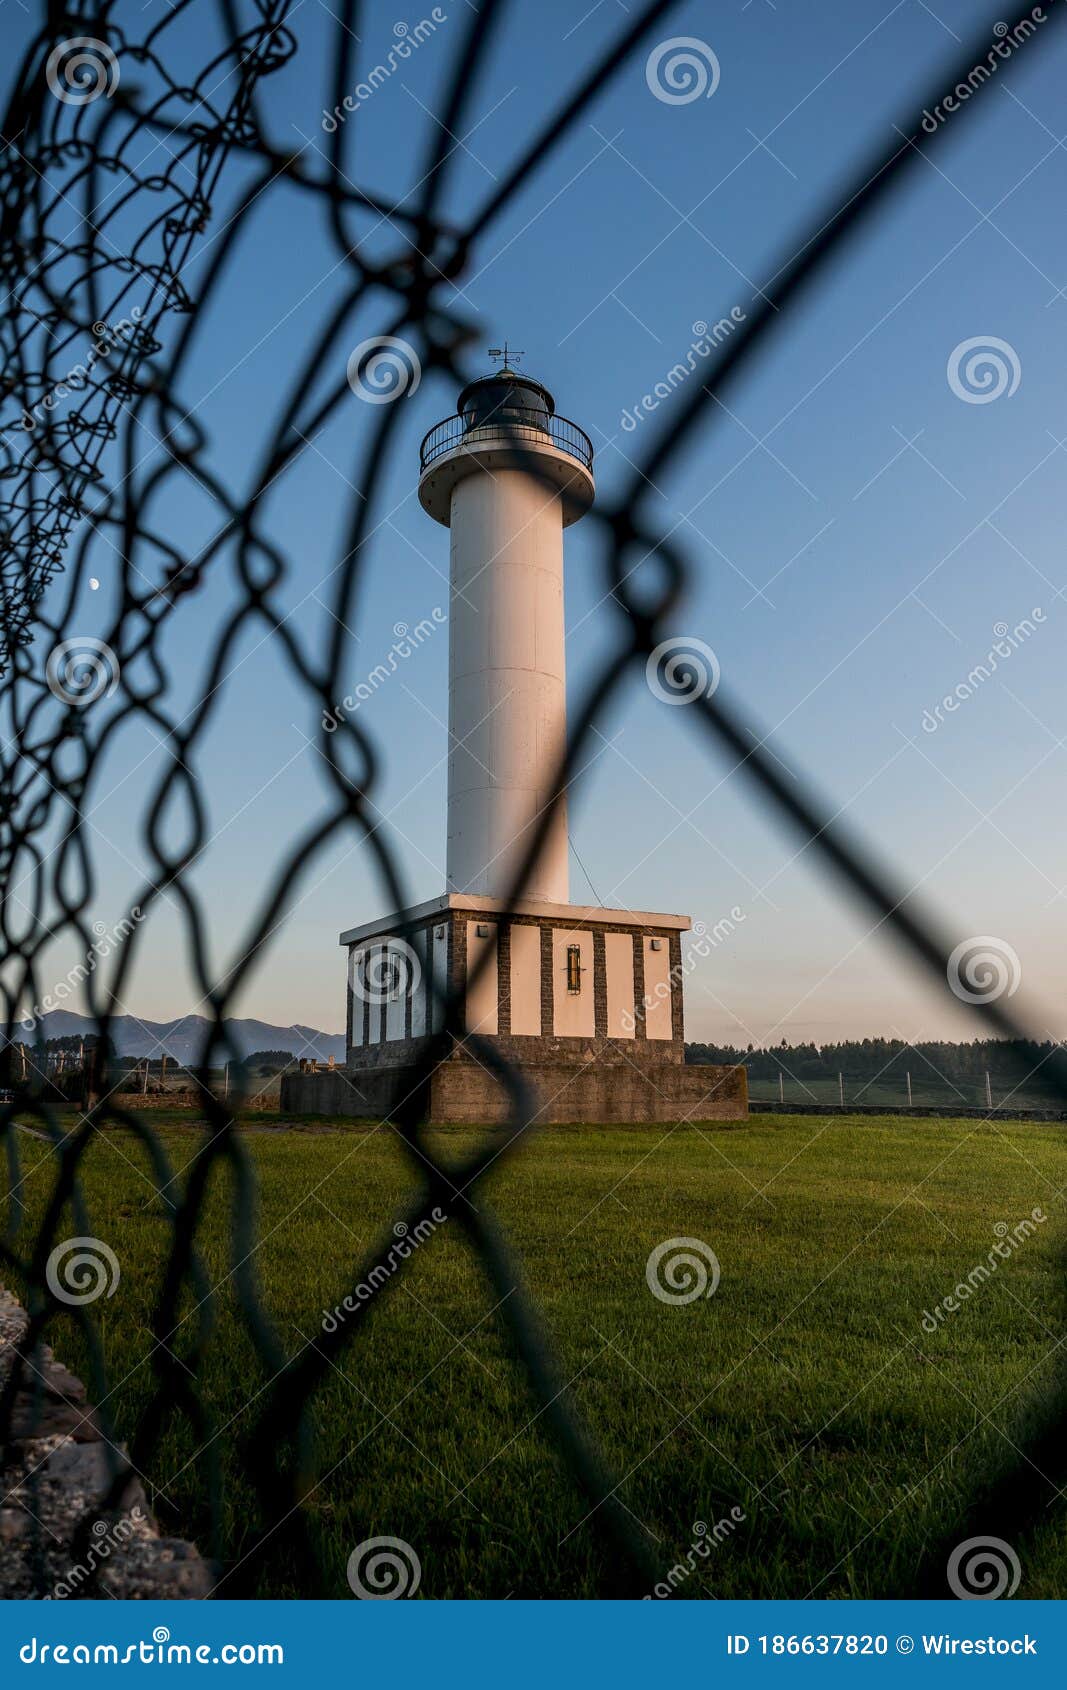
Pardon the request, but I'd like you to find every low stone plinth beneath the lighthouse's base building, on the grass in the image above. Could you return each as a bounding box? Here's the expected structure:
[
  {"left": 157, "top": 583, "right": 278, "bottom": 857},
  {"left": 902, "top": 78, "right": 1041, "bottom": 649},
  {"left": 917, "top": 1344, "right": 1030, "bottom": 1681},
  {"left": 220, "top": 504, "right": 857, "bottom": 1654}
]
[{"left": 281, "top": 1058, "right": 749, "bottom": 1126}]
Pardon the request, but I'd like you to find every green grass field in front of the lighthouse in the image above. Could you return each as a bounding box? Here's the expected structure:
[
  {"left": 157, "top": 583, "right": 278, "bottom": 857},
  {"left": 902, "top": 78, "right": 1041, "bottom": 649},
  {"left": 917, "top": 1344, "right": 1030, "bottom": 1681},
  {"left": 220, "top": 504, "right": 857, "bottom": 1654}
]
[{"left": 2, "top": 1115, "right": 1067, "bottom": 1597}]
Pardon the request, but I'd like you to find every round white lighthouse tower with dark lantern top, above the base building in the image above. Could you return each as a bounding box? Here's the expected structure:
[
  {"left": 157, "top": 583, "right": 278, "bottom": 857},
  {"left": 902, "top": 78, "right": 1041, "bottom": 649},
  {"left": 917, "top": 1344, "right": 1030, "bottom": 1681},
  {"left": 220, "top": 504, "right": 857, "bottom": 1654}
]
[{"left": 419, "top": 362, "right": 594, "bottom": 904}]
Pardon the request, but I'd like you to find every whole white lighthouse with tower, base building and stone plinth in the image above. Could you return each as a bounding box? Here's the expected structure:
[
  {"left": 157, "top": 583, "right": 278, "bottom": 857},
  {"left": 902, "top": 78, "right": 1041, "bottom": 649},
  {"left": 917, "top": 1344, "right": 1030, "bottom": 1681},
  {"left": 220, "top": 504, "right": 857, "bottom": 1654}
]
[{"left": 299, "top": 348, "right": 747, "bottom": 1124}]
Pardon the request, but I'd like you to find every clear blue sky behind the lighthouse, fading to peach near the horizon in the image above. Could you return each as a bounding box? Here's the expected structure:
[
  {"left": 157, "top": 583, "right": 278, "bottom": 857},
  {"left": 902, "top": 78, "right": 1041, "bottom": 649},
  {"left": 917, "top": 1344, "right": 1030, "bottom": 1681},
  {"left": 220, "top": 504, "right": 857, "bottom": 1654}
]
[{"left": 14, "top": 0, "right": 1067, "bottom": 1043}]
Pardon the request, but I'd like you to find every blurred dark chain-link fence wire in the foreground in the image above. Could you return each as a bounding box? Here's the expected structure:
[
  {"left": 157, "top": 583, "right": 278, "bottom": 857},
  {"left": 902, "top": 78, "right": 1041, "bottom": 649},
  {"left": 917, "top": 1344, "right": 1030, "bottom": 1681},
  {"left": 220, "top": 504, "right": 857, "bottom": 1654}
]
[{"left": 0, "top": 0, "right": 1067, "bottom": 1595}]
